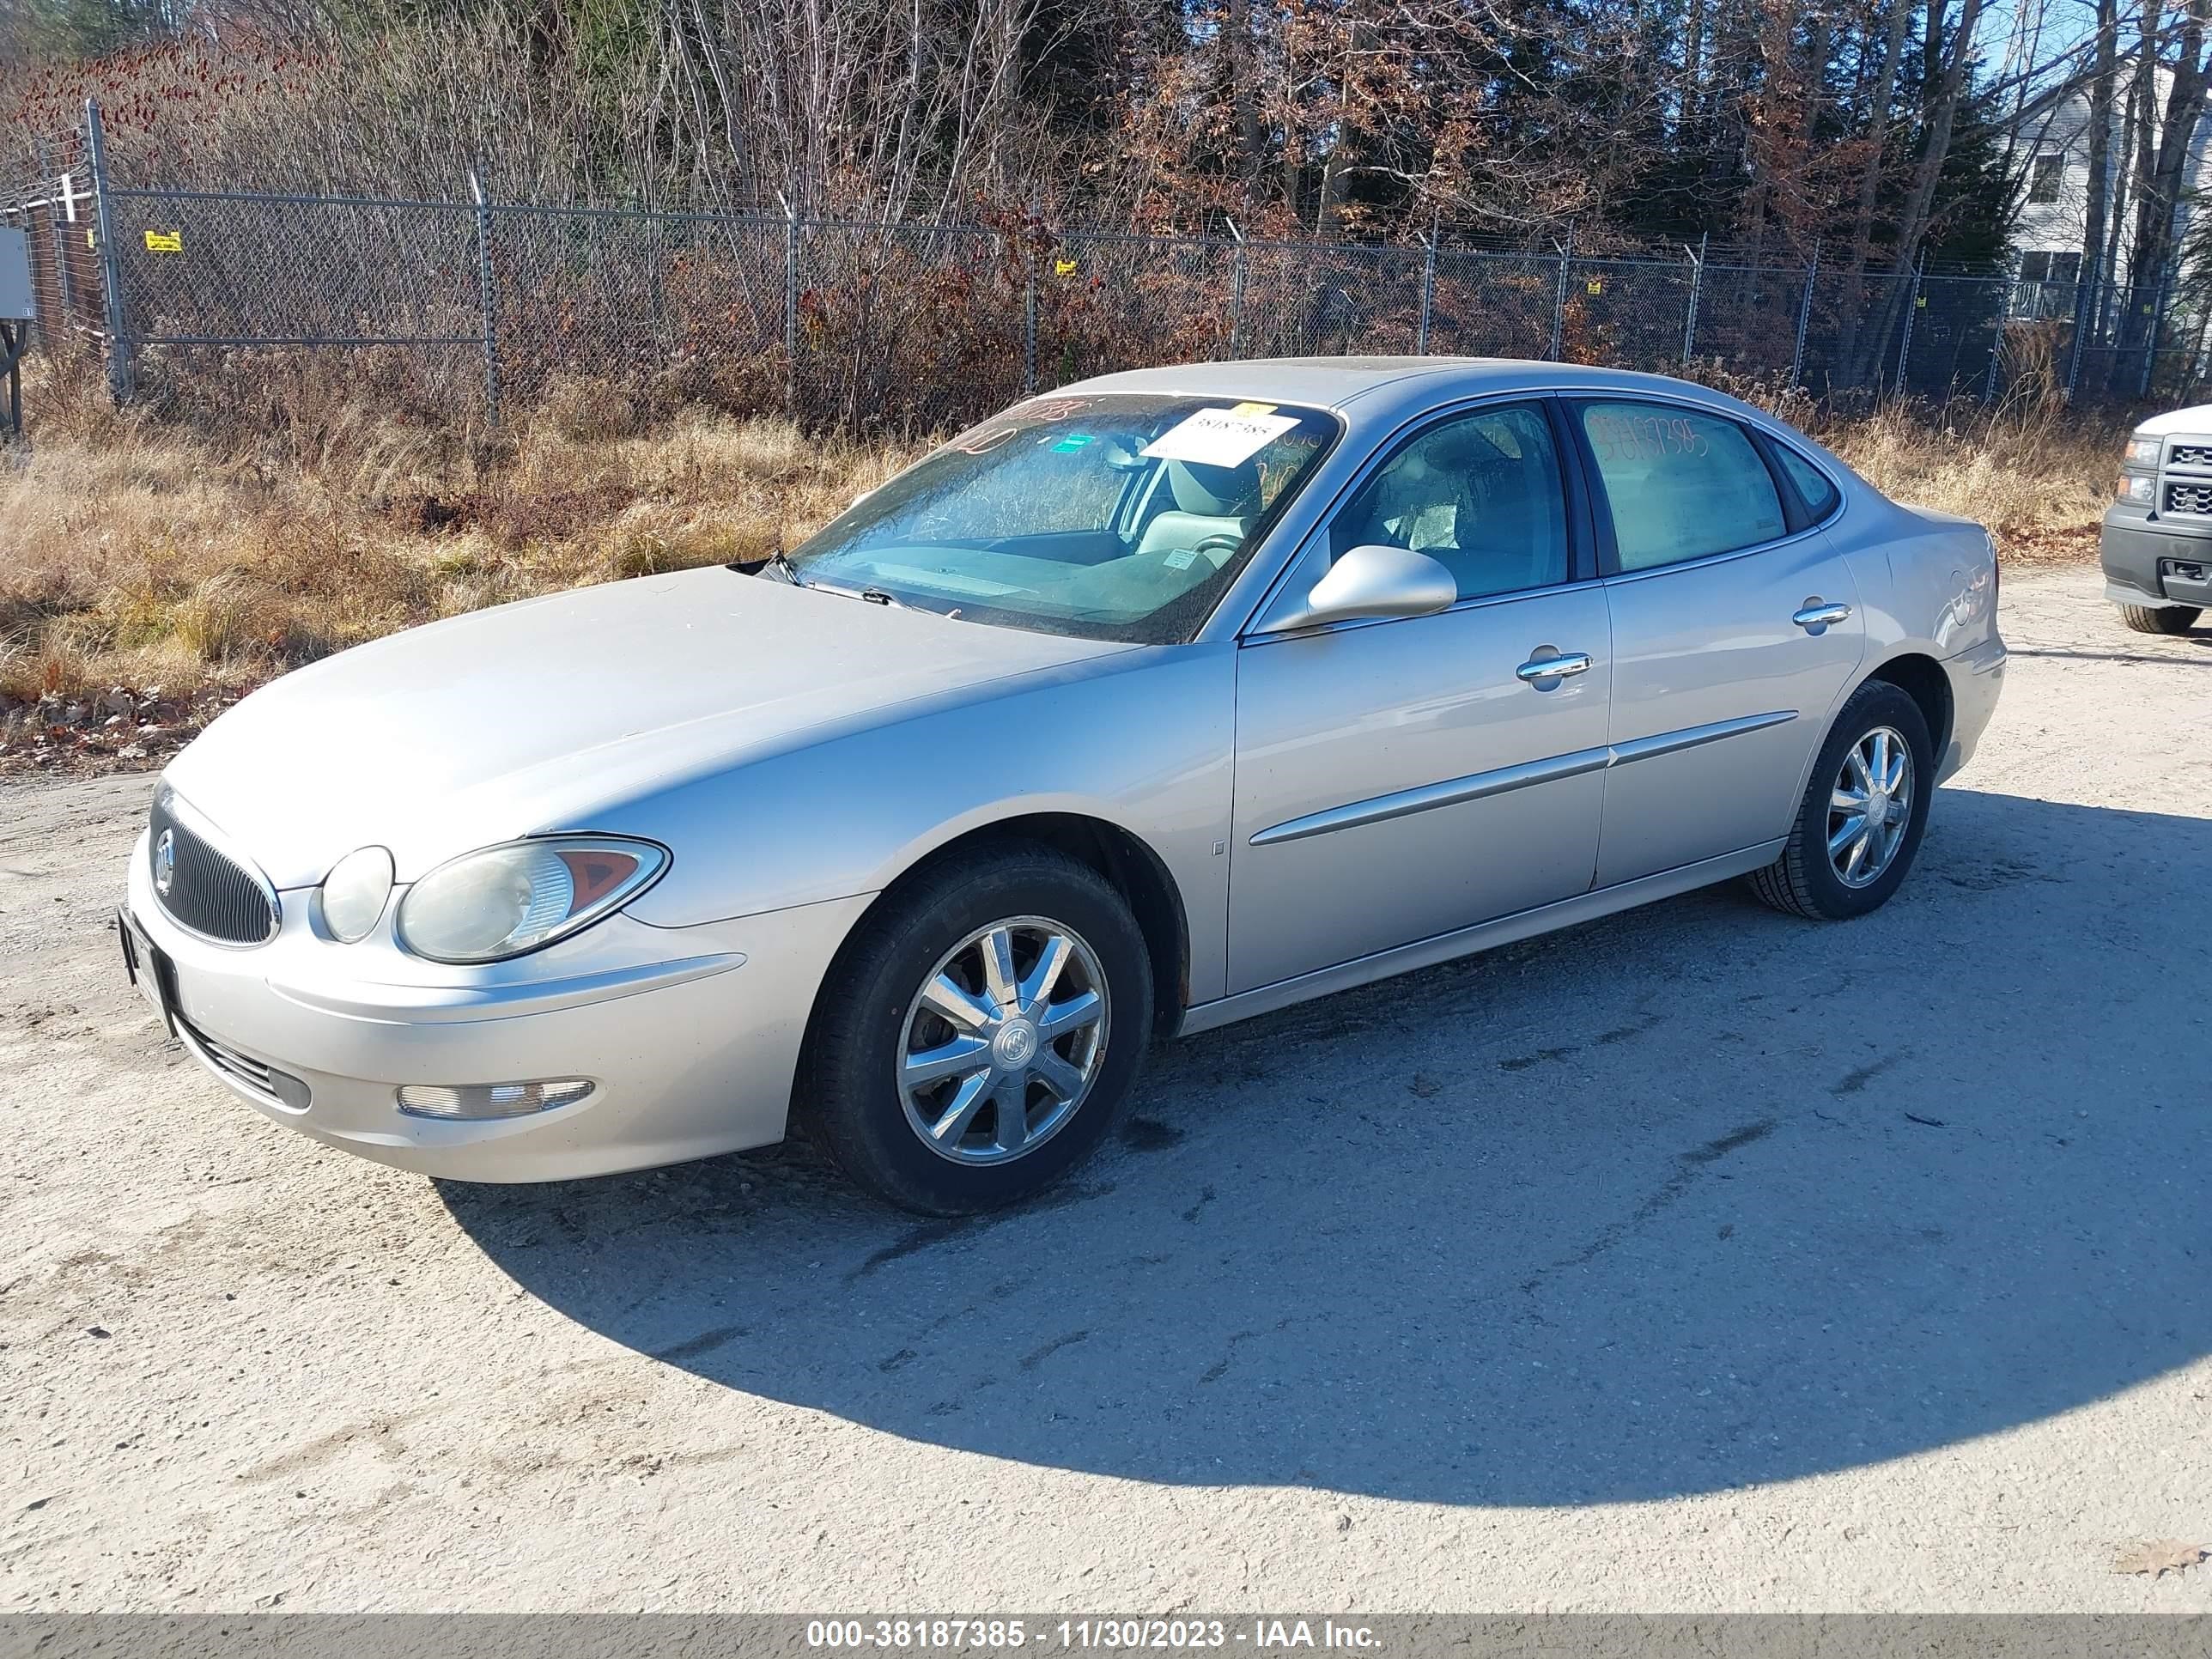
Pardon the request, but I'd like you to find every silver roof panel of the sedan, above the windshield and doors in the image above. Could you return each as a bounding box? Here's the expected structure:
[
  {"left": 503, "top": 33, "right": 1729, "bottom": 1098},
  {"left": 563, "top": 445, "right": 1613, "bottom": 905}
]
[{"left": 1060, "top": 356, "right": 1756, "bottom": 414}]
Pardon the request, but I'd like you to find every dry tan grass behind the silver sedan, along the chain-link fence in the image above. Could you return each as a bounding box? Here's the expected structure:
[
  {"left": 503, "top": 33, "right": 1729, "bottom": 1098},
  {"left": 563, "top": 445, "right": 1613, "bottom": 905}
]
[{"left": 0, "top": 380, "right": 2124, "bottom": 769}]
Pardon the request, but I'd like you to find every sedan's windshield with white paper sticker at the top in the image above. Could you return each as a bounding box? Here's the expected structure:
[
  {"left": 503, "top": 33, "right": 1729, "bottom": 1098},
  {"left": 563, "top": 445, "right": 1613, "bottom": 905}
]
[{"left": 790, "top": 394, "right": 1338, "bottom": 644}]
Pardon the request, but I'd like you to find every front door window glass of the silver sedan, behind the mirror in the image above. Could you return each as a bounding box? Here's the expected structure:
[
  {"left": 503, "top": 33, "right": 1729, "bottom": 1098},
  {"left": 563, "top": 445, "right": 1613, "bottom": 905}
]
[{"left": 1329, "top": 404, "right": 1566, "bottom": 599}]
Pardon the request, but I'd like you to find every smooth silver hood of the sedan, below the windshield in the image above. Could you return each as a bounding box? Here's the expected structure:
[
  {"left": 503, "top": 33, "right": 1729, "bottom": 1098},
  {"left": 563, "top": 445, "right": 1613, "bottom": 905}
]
[{"left": 166, "top": 568, "right": 1130, "bottom": 887}]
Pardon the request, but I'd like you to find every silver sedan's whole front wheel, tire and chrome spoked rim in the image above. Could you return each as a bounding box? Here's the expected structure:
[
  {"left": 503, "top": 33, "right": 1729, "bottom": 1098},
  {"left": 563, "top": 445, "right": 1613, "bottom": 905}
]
[{"left": 799, "top": 845, "right": 1152, "bottom": 1214}]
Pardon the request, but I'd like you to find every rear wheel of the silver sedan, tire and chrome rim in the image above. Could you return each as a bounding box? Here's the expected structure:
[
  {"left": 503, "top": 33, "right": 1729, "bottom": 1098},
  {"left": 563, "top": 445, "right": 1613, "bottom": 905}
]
[{"left": 1750, "top": 679, "right": 1936, "bottom": 922}]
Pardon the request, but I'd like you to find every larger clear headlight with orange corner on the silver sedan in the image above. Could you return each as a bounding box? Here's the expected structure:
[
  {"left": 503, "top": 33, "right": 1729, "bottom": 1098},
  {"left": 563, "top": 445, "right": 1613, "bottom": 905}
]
[{"left": 398, "top": 836, "right": 668, "bottom": 963}]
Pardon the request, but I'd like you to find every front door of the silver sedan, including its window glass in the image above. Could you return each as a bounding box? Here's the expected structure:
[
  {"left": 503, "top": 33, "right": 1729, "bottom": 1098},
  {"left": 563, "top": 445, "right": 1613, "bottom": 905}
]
[{"left": 1230, "top": 403, "right": 1613, "bottom": 994}]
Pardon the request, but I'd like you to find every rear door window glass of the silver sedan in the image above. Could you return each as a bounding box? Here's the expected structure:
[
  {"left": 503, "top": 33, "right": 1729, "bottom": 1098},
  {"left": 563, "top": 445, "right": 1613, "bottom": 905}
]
[{"left": 1582, "top": 403, "right": 1785, "bottom": 571}]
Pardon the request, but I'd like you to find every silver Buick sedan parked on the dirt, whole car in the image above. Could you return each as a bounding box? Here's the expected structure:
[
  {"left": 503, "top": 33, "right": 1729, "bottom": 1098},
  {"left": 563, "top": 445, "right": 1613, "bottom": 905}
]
[{"left": 119, "top": 358, "right": 2004, "bottom": 1214}]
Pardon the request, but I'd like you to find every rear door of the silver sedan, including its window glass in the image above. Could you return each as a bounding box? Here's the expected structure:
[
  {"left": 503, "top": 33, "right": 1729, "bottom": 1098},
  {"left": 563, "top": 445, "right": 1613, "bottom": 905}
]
[{"left": 1573, "top": 398, "right": 1867, "bottom": 887}]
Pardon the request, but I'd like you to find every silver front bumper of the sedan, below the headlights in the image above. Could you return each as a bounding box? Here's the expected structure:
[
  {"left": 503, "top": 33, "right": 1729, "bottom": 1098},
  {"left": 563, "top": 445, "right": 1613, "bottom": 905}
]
[{"left": 128, "top": 838, "right": 867, "bottom": 1182}]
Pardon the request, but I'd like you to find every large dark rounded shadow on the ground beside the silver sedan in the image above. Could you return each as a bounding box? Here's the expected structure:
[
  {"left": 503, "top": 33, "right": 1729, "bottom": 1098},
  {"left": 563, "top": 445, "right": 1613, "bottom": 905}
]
[{"left": 442, "top": 790, "right": 2212, "bottom": 1504}]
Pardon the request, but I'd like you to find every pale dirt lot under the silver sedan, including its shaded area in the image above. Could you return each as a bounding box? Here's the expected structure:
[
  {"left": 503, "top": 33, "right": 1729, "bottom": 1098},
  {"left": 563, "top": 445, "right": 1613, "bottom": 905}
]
[{"left": 0, "top": 573, "right": 2212, "bottom": 1613}]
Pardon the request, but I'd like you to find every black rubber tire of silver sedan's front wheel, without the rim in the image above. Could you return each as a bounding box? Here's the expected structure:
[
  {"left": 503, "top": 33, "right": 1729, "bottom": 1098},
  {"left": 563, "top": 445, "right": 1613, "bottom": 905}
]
[{"left": 794, "top": 841, "right": 1152, "bottom": 1217}]
